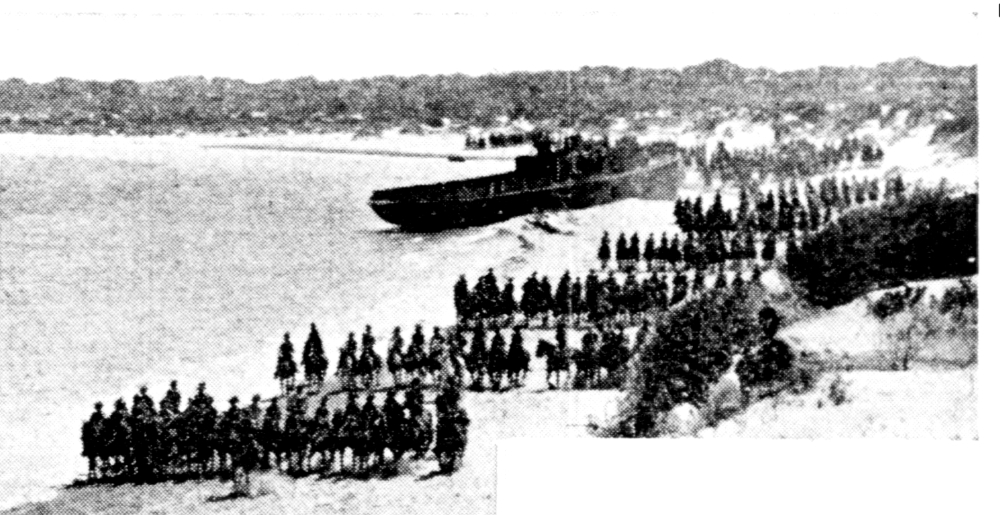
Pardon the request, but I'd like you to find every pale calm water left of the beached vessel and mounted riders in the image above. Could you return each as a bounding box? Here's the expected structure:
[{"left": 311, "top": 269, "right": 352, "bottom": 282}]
[{"left": 0, "top": 137, "right": 518, "bottom": 507}]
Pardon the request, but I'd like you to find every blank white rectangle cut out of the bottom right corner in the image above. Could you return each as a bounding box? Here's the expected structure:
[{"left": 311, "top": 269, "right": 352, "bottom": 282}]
[{"left": 497, "top": 439, "right": 1000, "bottom": 515}]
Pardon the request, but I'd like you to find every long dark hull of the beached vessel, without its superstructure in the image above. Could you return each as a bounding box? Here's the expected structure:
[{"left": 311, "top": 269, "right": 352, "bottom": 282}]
[{"left": 369, "top": 157, "right": 679, "bottom": 232}]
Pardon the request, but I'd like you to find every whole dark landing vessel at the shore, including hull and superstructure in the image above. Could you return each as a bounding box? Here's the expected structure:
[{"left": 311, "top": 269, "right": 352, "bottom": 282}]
[{"left": 368, "top": 136, "right": 679, "bottom": 232}]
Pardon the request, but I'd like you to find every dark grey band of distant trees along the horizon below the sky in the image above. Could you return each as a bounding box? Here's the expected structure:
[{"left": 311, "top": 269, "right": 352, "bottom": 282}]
[{"left": 0, "top": 59, "right": 976, "bottom": 133}]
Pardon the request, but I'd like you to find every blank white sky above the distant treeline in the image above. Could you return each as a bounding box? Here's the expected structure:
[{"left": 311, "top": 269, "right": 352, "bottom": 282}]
[{"left": 0, "top": 0, "right": 995, "bottom": 82}]
